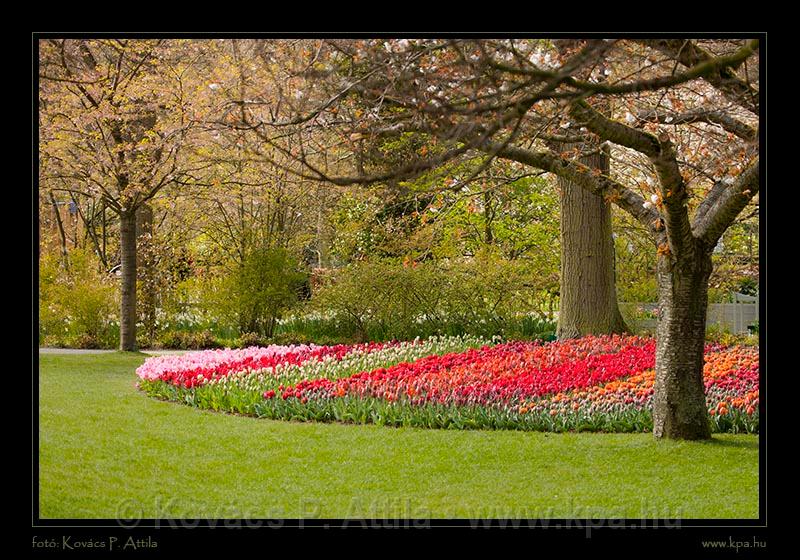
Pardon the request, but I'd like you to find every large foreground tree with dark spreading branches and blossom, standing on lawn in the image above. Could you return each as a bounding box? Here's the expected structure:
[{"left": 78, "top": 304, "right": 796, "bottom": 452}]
[{"left": 234, "top": 40, "right": 759, "bottom": 439}]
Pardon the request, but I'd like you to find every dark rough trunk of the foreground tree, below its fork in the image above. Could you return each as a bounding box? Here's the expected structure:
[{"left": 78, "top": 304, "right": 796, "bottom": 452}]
[{"left": 653, "top": 249, "right": 712, "bottom": 439}]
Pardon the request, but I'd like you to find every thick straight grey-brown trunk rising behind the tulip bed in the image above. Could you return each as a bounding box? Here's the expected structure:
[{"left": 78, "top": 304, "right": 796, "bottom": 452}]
[{"left": 558, "top": 152, "right": 628, "bottom": 338}]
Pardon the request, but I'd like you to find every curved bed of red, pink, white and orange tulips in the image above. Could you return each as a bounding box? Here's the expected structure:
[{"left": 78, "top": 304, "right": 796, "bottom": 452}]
[{"left": 137, "top": 335, "right": 759, "bottom": 432}]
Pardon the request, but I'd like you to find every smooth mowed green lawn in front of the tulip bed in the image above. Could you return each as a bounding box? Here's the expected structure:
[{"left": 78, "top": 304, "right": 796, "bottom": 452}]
[{"left": 39, "top": 353, "right": 758, "bottom": 519}]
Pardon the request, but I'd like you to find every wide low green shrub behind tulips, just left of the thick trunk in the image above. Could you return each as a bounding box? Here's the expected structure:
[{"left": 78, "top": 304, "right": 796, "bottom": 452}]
[{"left": 312, "top": 252, "right": 549, "bottom": 340}]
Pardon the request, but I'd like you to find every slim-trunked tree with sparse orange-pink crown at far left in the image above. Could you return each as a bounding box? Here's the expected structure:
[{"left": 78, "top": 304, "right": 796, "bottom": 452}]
[{"left": 39, "top": 39, "right": 212, "bottom": 350}]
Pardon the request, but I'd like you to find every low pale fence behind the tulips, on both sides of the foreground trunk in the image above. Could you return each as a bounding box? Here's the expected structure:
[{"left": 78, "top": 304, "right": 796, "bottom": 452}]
[{"left": 620, "top": 293, "right": 758, "bottom": 334}]
